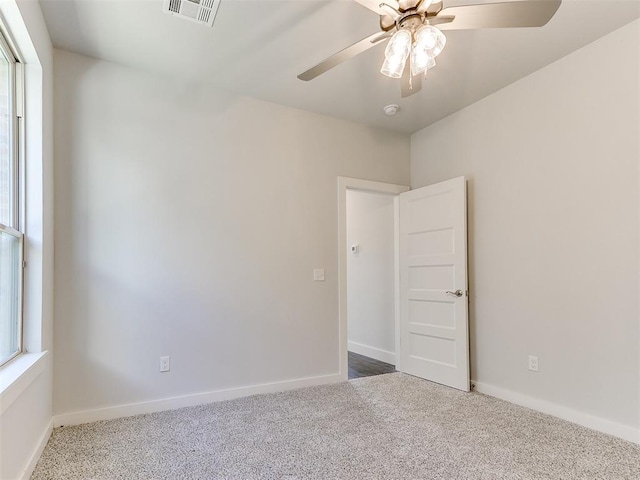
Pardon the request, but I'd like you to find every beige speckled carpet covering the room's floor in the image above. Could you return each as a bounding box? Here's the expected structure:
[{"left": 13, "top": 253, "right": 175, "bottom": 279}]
[{"left": 31, "top": 373, "right": 640, "bottom": 480}]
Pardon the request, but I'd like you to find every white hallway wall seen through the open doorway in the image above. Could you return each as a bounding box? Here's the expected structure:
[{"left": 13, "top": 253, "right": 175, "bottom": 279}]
[{"left": 347, "top": 190, "right": 395, "bottom": 365}]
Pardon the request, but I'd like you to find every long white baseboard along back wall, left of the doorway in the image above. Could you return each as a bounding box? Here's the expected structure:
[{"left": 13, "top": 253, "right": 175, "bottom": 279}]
[{"left": 53, "top": 374, "right": 344, "bottom": 427}]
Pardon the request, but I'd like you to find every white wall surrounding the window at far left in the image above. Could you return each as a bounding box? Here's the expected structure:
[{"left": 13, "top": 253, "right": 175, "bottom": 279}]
[{"left": 0, "top": 0, "right": 53, "bottom": 479}]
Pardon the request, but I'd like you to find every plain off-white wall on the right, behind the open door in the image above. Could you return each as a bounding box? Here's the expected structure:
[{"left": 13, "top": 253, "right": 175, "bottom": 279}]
[{"left": 411, "top": 21, "right": 640, "bottom": 441}]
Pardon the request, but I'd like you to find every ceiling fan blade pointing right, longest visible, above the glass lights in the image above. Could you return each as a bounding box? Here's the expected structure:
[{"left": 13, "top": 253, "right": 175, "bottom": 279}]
[{"left": 436, "top": 0, "right": 562, "bottom": 30}]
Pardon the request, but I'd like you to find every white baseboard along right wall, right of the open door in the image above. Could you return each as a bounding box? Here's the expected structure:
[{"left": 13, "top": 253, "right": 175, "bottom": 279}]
[{"left": 472, "top": 380, "right": 640, "bottom": 444}]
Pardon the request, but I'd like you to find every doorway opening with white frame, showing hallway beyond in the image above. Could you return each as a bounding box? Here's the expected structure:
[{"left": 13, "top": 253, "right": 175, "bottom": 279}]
[{"left": 338, "top": 177, "right": 409, "bottom": 380}]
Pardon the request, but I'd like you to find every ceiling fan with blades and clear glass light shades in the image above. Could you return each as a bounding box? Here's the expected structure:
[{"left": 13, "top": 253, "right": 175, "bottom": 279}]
[{"left": 298, "top": 0, "right": 562, "bottom": 98}]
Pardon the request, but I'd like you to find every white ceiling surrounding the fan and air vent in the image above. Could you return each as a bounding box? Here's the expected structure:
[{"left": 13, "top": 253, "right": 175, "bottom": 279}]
[{"left": 40, "top": 0, "right": 640, "bottom": 133}]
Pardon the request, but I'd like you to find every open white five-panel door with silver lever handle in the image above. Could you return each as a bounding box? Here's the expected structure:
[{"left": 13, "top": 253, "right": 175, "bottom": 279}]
[{"left": 399, "top": 177, "right": 469, "bottom": 391}]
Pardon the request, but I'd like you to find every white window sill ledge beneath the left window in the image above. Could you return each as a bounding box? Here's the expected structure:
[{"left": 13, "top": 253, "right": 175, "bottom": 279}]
[{"left": 0, "top": 352, "right": 48, "bottom": 415}]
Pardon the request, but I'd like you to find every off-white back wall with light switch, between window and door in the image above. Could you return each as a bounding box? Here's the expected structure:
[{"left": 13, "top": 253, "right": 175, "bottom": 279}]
[{"left": 54, "top": 51, "right": 409, "bottom": 418}]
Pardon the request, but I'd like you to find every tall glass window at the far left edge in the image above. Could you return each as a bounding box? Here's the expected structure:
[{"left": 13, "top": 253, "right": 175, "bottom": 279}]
[{"left": 0, "top": 30, "right": 24, "bottom": 365}]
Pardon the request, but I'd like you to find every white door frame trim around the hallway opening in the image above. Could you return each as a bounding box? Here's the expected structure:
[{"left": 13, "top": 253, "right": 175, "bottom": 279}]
[{"left": 338, "top": 177, "right": 411, "bottom": 380}]
